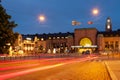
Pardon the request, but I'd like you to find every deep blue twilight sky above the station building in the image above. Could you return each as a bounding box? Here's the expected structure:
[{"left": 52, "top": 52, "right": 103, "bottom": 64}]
[{"left": 1, "top": 0, "right": 120, "bottom": 34}]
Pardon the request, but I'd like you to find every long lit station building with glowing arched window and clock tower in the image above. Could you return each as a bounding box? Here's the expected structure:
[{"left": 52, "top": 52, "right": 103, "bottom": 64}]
[{"left": 15, "top": 17, "right": 120, "bottom": 54}]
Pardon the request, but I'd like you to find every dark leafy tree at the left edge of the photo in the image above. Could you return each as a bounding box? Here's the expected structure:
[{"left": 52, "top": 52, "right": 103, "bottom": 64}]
[{"left": 0, "top": 4, "right": 17, "bottom": 54}]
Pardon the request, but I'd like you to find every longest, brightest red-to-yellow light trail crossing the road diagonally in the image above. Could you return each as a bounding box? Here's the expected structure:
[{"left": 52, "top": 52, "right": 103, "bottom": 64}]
[{"left": 0, "top": 57, "right": 97, "bottom": 80}]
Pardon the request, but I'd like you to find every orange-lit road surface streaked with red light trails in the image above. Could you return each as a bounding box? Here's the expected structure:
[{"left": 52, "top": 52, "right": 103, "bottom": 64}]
[{"left": 0, "top": 57, "right": 111, "bottom": 80}]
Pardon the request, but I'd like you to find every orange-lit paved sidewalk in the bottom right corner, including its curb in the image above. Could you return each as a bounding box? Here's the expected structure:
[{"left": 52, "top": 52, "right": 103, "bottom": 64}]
[{"left": 105, "top": 60, "right": 120, "bottom": 80}]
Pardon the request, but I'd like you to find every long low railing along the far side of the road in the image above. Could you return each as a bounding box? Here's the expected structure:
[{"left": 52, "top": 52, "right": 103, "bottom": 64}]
[{"left": 0, "top": 53, "right": 82, "bottom": 61}]
